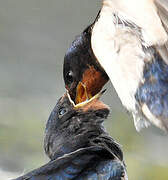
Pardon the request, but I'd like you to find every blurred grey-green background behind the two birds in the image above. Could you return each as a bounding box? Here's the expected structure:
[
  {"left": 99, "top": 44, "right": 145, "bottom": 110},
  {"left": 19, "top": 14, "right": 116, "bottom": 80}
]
[{"left": 0, "top": 0, "right": 168, "bottom": 180}]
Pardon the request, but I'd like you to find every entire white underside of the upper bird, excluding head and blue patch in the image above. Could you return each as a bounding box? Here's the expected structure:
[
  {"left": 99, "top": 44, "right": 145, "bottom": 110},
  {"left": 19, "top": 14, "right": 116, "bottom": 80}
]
[{"left": 91, "top": 0, "right": 168, "bottom": 131}]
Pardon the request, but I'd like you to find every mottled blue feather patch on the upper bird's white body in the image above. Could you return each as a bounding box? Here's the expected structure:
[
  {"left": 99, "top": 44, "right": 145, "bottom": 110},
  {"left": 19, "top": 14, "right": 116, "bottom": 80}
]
[{"left": 136, "top": 50, "right": 168, "bottom": 130}]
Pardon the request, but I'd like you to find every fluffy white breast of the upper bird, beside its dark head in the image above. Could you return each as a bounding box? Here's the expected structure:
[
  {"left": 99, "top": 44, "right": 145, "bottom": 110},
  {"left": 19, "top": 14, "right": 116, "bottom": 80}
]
[{"left": 91, "top": 9, "right": 149, "bottom": 111}]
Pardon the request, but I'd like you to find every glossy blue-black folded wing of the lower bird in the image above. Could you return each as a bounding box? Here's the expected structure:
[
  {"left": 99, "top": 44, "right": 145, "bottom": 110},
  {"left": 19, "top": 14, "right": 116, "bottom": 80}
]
[{"left": 12, "top": 147, "right": 127, "bottom": 180}]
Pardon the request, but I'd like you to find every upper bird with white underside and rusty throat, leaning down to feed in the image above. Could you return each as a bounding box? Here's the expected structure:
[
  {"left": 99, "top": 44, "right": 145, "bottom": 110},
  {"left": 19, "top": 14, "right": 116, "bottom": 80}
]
[{"left": 64, "top": 0, "right": 168, "bottom": 131}]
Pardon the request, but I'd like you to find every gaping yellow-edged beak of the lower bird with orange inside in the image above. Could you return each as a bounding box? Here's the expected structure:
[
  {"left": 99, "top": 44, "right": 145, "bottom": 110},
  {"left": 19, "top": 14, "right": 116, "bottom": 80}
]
[{"left": 67, "top": 82, "right": 106, "bottom": 109}]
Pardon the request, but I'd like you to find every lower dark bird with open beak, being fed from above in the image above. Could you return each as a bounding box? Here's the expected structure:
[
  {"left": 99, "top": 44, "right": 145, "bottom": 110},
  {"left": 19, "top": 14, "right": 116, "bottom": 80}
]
[{"left": 16, "top": 90, "right": 127, "bottom": 180}]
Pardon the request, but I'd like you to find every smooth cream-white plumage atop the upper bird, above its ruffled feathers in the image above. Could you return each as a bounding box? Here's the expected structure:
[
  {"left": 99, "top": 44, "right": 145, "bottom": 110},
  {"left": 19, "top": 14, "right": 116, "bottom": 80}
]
[{"left": 103, "top": 0, "right": 168, "bottom": 46}]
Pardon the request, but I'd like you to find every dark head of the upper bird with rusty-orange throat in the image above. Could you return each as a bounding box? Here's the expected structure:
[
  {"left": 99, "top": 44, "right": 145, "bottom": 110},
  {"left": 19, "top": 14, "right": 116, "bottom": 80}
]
[{"left": 63, "top": 26, "right": 109, "bottom": 104}]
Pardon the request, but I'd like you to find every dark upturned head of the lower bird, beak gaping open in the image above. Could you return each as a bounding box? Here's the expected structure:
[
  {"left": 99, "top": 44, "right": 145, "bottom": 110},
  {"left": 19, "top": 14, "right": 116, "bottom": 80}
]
[{"left": 44, "top": 87, "right": 109, "bottom": 159}]
